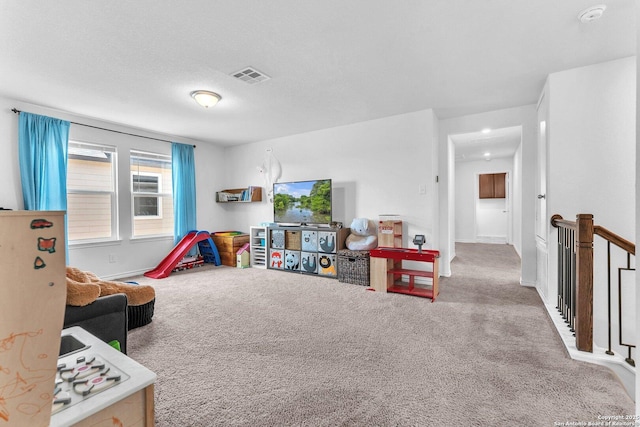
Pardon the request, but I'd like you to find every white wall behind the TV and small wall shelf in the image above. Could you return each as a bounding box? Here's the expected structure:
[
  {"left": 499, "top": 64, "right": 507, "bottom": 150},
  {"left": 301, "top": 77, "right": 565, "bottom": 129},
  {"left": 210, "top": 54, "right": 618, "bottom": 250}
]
[{"left": 221, "top": 110, "right": 438, "bottom": 248}]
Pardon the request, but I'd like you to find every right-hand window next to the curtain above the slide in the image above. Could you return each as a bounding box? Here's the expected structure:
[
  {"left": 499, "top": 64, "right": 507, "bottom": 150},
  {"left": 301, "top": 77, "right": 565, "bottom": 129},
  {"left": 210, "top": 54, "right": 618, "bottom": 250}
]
[{"left": 131, "top": 151, "right": 173, "bottom": 237}]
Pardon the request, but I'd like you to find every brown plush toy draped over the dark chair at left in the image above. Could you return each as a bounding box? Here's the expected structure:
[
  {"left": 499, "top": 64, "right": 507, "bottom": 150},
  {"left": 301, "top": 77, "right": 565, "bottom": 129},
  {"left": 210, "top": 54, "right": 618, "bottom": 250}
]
[{"left": 67, "top": 267, "right": 156, "bottom": 306}]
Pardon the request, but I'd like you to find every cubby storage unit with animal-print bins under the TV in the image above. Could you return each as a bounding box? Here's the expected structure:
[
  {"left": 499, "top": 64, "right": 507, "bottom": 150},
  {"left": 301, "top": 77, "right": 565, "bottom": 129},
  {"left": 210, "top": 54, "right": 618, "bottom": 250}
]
[{"left": 267, "top": 226, "right": 350, "bottom": 277}]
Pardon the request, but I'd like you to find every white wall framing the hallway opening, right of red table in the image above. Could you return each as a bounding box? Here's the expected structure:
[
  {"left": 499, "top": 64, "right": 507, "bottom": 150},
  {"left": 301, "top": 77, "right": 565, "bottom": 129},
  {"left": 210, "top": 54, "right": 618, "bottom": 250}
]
[{"left": 438, "top": 105, "right": 536, "bottom": 286}]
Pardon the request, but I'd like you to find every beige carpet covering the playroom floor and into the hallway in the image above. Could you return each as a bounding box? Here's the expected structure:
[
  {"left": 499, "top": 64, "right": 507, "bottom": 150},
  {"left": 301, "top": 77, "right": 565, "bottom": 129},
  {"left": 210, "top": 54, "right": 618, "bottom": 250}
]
[{"left": 129, "top": 244, "right": 635, "bottom": 427}]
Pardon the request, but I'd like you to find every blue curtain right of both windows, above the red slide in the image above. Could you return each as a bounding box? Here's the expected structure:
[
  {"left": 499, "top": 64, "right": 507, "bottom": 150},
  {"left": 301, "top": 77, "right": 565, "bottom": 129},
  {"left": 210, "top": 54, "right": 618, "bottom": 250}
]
[{"left": 171, "top": 142, "right": 197, "bottom": 244}]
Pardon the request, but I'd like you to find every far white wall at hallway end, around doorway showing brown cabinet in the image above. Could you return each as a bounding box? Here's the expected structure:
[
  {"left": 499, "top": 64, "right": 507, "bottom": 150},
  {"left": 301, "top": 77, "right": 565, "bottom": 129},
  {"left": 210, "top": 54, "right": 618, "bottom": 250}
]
[{"left": 455, "top": 157, "right": 514, "bottom": 242}]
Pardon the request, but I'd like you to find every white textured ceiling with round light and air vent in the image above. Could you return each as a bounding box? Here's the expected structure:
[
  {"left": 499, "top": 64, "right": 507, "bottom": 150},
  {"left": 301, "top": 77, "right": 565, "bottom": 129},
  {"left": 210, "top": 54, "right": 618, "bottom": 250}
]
[{"left": 0, "top": 0, "right": 636, "bottom": 145}]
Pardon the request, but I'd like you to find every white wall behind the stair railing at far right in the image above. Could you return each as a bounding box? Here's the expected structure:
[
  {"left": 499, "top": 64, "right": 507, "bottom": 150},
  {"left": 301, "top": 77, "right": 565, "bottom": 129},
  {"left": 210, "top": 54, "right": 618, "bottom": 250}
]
[{"left": 546, "top": 58, "right": 636, "bottom": 347}]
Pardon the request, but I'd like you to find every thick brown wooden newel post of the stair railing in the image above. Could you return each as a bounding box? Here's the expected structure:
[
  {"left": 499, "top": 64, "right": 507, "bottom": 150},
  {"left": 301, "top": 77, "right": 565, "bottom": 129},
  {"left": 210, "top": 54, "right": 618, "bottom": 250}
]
[{"left": 575, "top": 214, "right": 593, "bottom": 353}]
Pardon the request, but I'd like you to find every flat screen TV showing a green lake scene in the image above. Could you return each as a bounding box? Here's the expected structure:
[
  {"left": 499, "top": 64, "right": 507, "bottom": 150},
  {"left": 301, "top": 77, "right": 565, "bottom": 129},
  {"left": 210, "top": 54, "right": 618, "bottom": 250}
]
[{"left": 273, "top": 179, "right": 331, "bottom": 225}]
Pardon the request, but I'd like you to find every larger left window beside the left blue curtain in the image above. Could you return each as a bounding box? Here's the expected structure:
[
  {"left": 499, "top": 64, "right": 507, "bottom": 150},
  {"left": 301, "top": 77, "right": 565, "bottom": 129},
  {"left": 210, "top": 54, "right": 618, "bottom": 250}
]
[{"left": 67, "top": 141, "right": 118, "bottom": 243}]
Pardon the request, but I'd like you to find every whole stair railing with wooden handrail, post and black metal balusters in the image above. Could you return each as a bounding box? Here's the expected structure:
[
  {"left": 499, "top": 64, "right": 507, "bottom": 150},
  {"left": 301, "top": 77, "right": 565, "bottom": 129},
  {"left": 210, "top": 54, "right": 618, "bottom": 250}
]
[{"left": 551, "top": 214, "right": 636, "bottom": 366}]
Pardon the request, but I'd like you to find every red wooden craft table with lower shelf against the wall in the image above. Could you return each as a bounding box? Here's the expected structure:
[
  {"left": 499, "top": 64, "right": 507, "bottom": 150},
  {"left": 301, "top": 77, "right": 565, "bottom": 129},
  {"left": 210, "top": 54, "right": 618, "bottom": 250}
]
[{"left": 369, "top": 248, "right": 440, "bottom": 302}]
